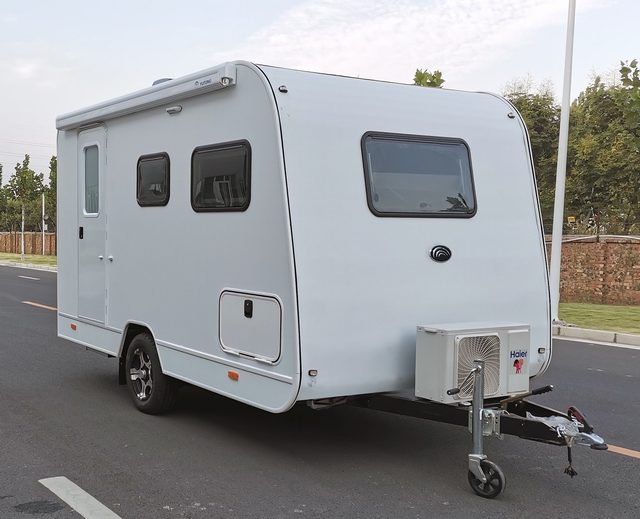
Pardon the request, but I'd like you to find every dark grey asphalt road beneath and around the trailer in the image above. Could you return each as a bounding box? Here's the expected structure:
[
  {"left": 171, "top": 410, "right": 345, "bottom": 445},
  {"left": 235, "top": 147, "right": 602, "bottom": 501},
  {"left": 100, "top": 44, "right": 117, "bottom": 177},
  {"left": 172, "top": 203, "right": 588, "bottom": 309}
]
[{"left": 0, "top": 267, "right": 640, "bottom": 519}]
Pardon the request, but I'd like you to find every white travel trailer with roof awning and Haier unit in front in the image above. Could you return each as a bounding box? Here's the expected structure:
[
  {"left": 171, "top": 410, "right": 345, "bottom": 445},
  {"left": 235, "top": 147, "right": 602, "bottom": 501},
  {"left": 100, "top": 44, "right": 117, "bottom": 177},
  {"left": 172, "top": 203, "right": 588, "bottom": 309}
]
[{"left": 57, "top": 61, "right": 604, "bottom": 496}]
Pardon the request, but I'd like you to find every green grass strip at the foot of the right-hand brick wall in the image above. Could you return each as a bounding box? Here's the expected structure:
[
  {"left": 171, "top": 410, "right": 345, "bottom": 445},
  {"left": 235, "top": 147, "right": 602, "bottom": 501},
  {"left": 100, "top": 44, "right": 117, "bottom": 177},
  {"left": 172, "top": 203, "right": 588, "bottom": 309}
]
[{"left": 558, "top": 303, "right": 640, "bottom": 334}]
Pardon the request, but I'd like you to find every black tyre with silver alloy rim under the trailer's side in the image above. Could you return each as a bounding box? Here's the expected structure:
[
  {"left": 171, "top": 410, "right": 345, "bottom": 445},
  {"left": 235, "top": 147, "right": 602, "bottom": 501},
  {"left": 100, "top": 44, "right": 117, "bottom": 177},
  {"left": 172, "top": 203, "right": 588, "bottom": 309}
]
[{"left": 125, "top": 333, "right": 177, "bottom": 414}]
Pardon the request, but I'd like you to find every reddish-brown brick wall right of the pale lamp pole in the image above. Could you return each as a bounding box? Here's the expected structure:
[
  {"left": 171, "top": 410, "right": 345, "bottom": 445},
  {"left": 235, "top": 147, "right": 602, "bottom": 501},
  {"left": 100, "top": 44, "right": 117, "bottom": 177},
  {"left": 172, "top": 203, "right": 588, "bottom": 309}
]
[{"left": 547, "top": 236, "right": 640, "bottom": 305}]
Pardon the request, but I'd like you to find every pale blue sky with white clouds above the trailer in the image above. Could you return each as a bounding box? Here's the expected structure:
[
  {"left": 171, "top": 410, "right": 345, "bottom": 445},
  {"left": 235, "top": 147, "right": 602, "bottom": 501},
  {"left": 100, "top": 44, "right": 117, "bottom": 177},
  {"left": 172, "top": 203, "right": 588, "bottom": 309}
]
[{"left": 0, "top": 0, "right": 640, "bottom": 182}]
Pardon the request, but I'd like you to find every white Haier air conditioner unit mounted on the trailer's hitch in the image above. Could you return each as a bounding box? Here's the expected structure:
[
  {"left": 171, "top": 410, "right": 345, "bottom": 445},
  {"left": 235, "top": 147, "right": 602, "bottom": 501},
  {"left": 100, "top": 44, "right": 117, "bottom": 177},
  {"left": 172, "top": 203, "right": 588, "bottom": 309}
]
[{"left": 416, "top": 323, "right": 530, "bottom": 404}]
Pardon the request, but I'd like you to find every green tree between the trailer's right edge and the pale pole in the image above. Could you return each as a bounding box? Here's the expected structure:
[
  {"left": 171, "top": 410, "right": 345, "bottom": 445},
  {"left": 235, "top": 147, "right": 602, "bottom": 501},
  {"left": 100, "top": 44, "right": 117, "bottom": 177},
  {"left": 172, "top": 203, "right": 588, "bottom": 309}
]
[{"left": 504, "top": 79, "right": 560, "bottom": 232}]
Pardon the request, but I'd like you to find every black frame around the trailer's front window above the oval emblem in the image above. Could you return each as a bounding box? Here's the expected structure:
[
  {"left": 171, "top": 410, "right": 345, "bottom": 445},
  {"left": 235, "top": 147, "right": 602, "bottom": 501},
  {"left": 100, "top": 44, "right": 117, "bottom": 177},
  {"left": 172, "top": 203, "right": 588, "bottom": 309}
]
[{"left": 360, "top": 131, "right": 478, "bottom": 218}]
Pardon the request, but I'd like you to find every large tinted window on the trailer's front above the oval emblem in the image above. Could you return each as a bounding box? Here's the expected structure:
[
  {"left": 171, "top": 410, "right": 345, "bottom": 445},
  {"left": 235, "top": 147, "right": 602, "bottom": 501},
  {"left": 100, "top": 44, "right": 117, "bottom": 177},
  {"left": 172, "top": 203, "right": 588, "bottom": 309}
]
[{"left": 362, "top": 133, "right": 476, "bottom": 218}]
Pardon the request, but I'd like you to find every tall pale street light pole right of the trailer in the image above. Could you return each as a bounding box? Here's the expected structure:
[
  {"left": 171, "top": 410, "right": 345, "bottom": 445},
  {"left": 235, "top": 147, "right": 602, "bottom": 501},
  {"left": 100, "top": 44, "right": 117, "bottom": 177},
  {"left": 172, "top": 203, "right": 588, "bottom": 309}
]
[{"left": 549, "top": 0, "right": 576, "bottom": 321}]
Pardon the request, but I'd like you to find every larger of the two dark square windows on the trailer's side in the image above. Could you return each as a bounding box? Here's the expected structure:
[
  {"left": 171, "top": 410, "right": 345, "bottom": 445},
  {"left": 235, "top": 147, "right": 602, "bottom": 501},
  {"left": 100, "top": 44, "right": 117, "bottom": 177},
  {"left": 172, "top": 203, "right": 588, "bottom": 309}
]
[{"left": 191, "top": 141, "right": 251, "bottom": 212}]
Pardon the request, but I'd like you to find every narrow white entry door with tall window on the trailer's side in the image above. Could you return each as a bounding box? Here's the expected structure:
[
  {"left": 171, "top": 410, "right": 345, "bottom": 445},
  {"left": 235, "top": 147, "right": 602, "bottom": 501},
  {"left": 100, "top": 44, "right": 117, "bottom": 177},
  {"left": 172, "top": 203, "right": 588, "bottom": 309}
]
[{"left": 77, "top": 127, "right": 108, "bottom": 323}]
